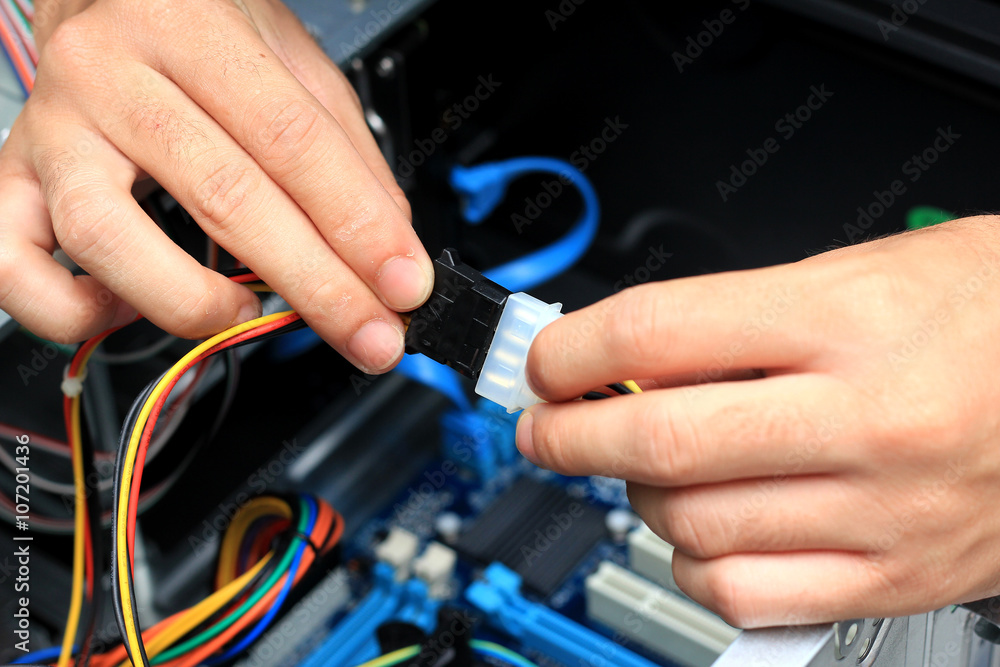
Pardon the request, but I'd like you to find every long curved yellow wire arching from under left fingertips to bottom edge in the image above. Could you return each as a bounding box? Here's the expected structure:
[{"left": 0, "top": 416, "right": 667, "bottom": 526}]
[{"left": 115, "top": 311, "right": 294, "bottom": 660}]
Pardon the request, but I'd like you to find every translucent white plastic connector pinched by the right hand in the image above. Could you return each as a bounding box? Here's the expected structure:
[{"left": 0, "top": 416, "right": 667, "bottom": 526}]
[{"left": 476, "top": 292, "right": 562, "bottom": 412}]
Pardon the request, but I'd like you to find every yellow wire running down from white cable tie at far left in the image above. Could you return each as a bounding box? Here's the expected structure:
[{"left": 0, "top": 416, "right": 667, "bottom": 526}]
[{"left": 56, "top": 345, "right": 101, "bottom": 667}]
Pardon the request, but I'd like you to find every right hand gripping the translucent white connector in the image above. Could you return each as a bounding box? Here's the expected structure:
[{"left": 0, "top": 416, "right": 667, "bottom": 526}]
[{"left": 517, "top": 217, "right": 1000, "bottom": 627}]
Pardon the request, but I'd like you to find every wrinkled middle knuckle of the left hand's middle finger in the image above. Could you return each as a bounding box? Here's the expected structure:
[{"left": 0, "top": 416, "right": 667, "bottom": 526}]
[{"left": 192, "top": 160, "right": 261, "bottom": 233}]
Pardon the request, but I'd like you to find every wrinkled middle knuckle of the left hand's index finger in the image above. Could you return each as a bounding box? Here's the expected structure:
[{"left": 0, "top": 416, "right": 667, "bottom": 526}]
[{"left": 252, "top": 98, "right": 323, "bottom": 177}]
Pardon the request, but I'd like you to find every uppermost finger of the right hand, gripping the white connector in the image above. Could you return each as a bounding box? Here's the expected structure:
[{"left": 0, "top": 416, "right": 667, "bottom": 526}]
[{"left": 526, "top": 266, "right": 815, "bottom": 401}]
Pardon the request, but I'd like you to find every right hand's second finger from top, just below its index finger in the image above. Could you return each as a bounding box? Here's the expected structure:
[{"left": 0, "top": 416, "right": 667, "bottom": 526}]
[{"left": 517, "top": 373, "right": 852, "bottom": 487}]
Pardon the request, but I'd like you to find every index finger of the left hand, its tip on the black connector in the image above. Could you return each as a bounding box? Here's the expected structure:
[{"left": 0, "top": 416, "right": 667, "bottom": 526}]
[{"left": 136, "top": 2, "right": 433, "bottom": 310}]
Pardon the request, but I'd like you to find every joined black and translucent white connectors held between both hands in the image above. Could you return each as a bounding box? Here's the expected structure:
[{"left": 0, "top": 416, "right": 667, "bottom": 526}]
[{"left": 406, "top": 249, "right": 562, "bottom": 412}]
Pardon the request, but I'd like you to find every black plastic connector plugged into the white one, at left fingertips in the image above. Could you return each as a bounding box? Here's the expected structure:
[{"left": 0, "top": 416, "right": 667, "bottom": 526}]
[{"left": 406, "top": 248, "right": 510, "bottom": 379}]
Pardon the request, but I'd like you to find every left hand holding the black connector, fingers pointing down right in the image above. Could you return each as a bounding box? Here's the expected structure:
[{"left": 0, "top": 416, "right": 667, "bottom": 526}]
[{"left": 0, "top": 0, "right": 433, "bottom": 372}]
